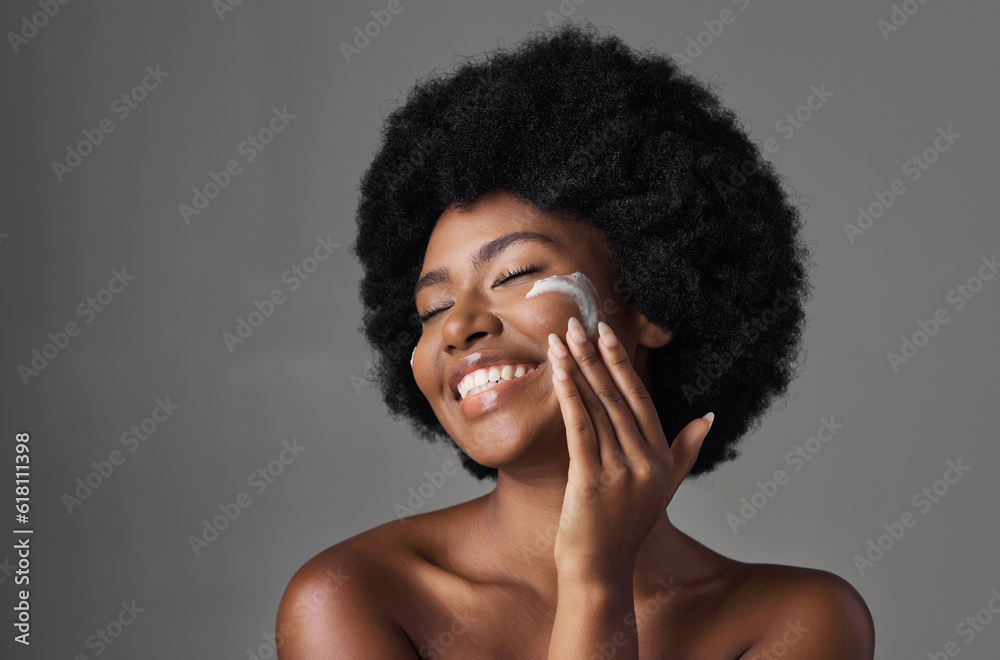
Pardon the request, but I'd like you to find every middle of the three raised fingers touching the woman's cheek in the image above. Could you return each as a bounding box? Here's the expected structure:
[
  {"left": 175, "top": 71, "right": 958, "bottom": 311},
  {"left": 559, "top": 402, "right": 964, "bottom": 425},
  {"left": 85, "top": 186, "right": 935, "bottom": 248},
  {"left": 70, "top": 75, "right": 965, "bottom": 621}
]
[{"left": 566, "top": 317, "right": 649, "bottom": 461}]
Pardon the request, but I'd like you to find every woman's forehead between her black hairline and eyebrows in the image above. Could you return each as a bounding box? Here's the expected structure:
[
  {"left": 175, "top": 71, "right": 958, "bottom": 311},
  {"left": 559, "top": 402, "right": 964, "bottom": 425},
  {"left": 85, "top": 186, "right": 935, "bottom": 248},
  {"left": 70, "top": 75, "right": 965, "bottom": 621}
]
[{"left": 424, "top": 191, "right": 607, "bottom": 270}]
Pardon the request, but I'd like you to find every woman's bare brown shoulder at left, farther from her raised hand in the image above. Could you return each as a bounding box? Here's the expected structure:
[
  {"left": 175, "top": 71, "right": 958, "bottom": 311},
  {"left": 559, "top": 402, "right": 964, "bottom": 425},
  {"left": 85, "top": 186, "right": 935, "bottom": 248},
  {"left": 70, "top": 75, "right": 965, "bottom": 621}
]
[{"left": 276, "top": 521, "right": 434, "bottom": 660}]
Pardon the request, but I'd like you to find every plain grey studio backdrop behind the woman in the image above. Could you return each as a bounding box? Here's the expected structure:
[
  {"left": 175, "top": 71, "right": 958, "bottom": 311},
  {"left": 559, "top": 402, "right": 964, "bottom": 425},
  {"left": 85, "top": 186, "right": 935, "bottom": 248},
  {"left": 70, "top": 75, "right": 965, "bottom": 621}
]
[{"left": 0, "top": 0, "right": 1000, "bottom": 659}]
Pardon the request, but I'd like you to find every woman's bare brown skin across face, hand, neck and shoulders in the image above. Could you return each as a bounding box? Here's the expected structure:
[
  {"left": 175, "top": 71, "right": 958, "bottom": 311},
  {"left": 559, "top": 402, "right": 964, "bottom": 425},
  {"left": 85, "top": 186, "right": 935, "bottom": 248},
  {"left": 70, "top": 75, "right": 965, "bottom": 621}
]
[{"left": 276, "top": 192, "right": 875, "bottom": 660}]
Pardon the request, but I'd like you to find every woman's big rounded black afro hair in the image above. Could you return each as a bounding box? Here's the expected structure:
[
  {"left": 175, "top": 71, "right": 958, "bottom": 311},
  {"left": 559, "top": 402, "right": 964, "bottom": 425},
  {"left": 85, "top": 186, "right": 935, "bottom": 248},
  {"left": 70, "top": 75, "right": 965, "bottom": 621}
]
[{"left": 350, "top": 22, "right": 811, "bottom": 479}]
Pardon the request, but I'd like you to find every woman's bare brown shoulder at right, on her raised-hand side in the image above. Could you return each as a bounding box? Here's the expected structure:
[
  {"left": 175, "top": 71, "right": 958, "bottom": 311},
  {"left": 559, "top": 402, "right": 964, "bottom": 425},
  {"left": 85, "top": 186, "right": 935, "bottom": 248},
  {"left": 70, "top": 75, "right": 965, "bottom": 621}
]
[{"left": 732, "top": 564, "right": 875, "bottom": 660}]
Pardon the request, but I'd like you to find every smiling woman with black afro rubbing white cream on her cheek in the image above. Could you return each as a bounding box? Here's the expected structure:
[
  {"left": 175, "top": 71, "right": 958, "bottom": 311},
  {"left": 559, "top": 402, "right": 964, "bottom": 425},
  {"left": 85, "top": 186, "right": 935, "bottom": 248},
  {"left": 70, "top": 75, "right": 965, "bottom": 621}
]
[{"left": 277, "top": 24, "right": 874, "bottom": 660}]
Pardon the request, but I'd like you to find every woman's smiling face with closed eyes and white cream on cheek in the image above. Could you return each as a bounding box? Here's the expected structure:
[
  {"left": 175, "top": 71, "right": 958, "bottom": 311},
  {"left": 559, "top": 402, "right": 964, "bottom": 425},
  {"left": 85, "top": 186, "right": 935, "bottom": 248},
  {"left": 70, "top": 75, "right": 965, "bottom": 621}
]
[{"left": 413, "top": 192, "right": 638, "bottom": 469}]
